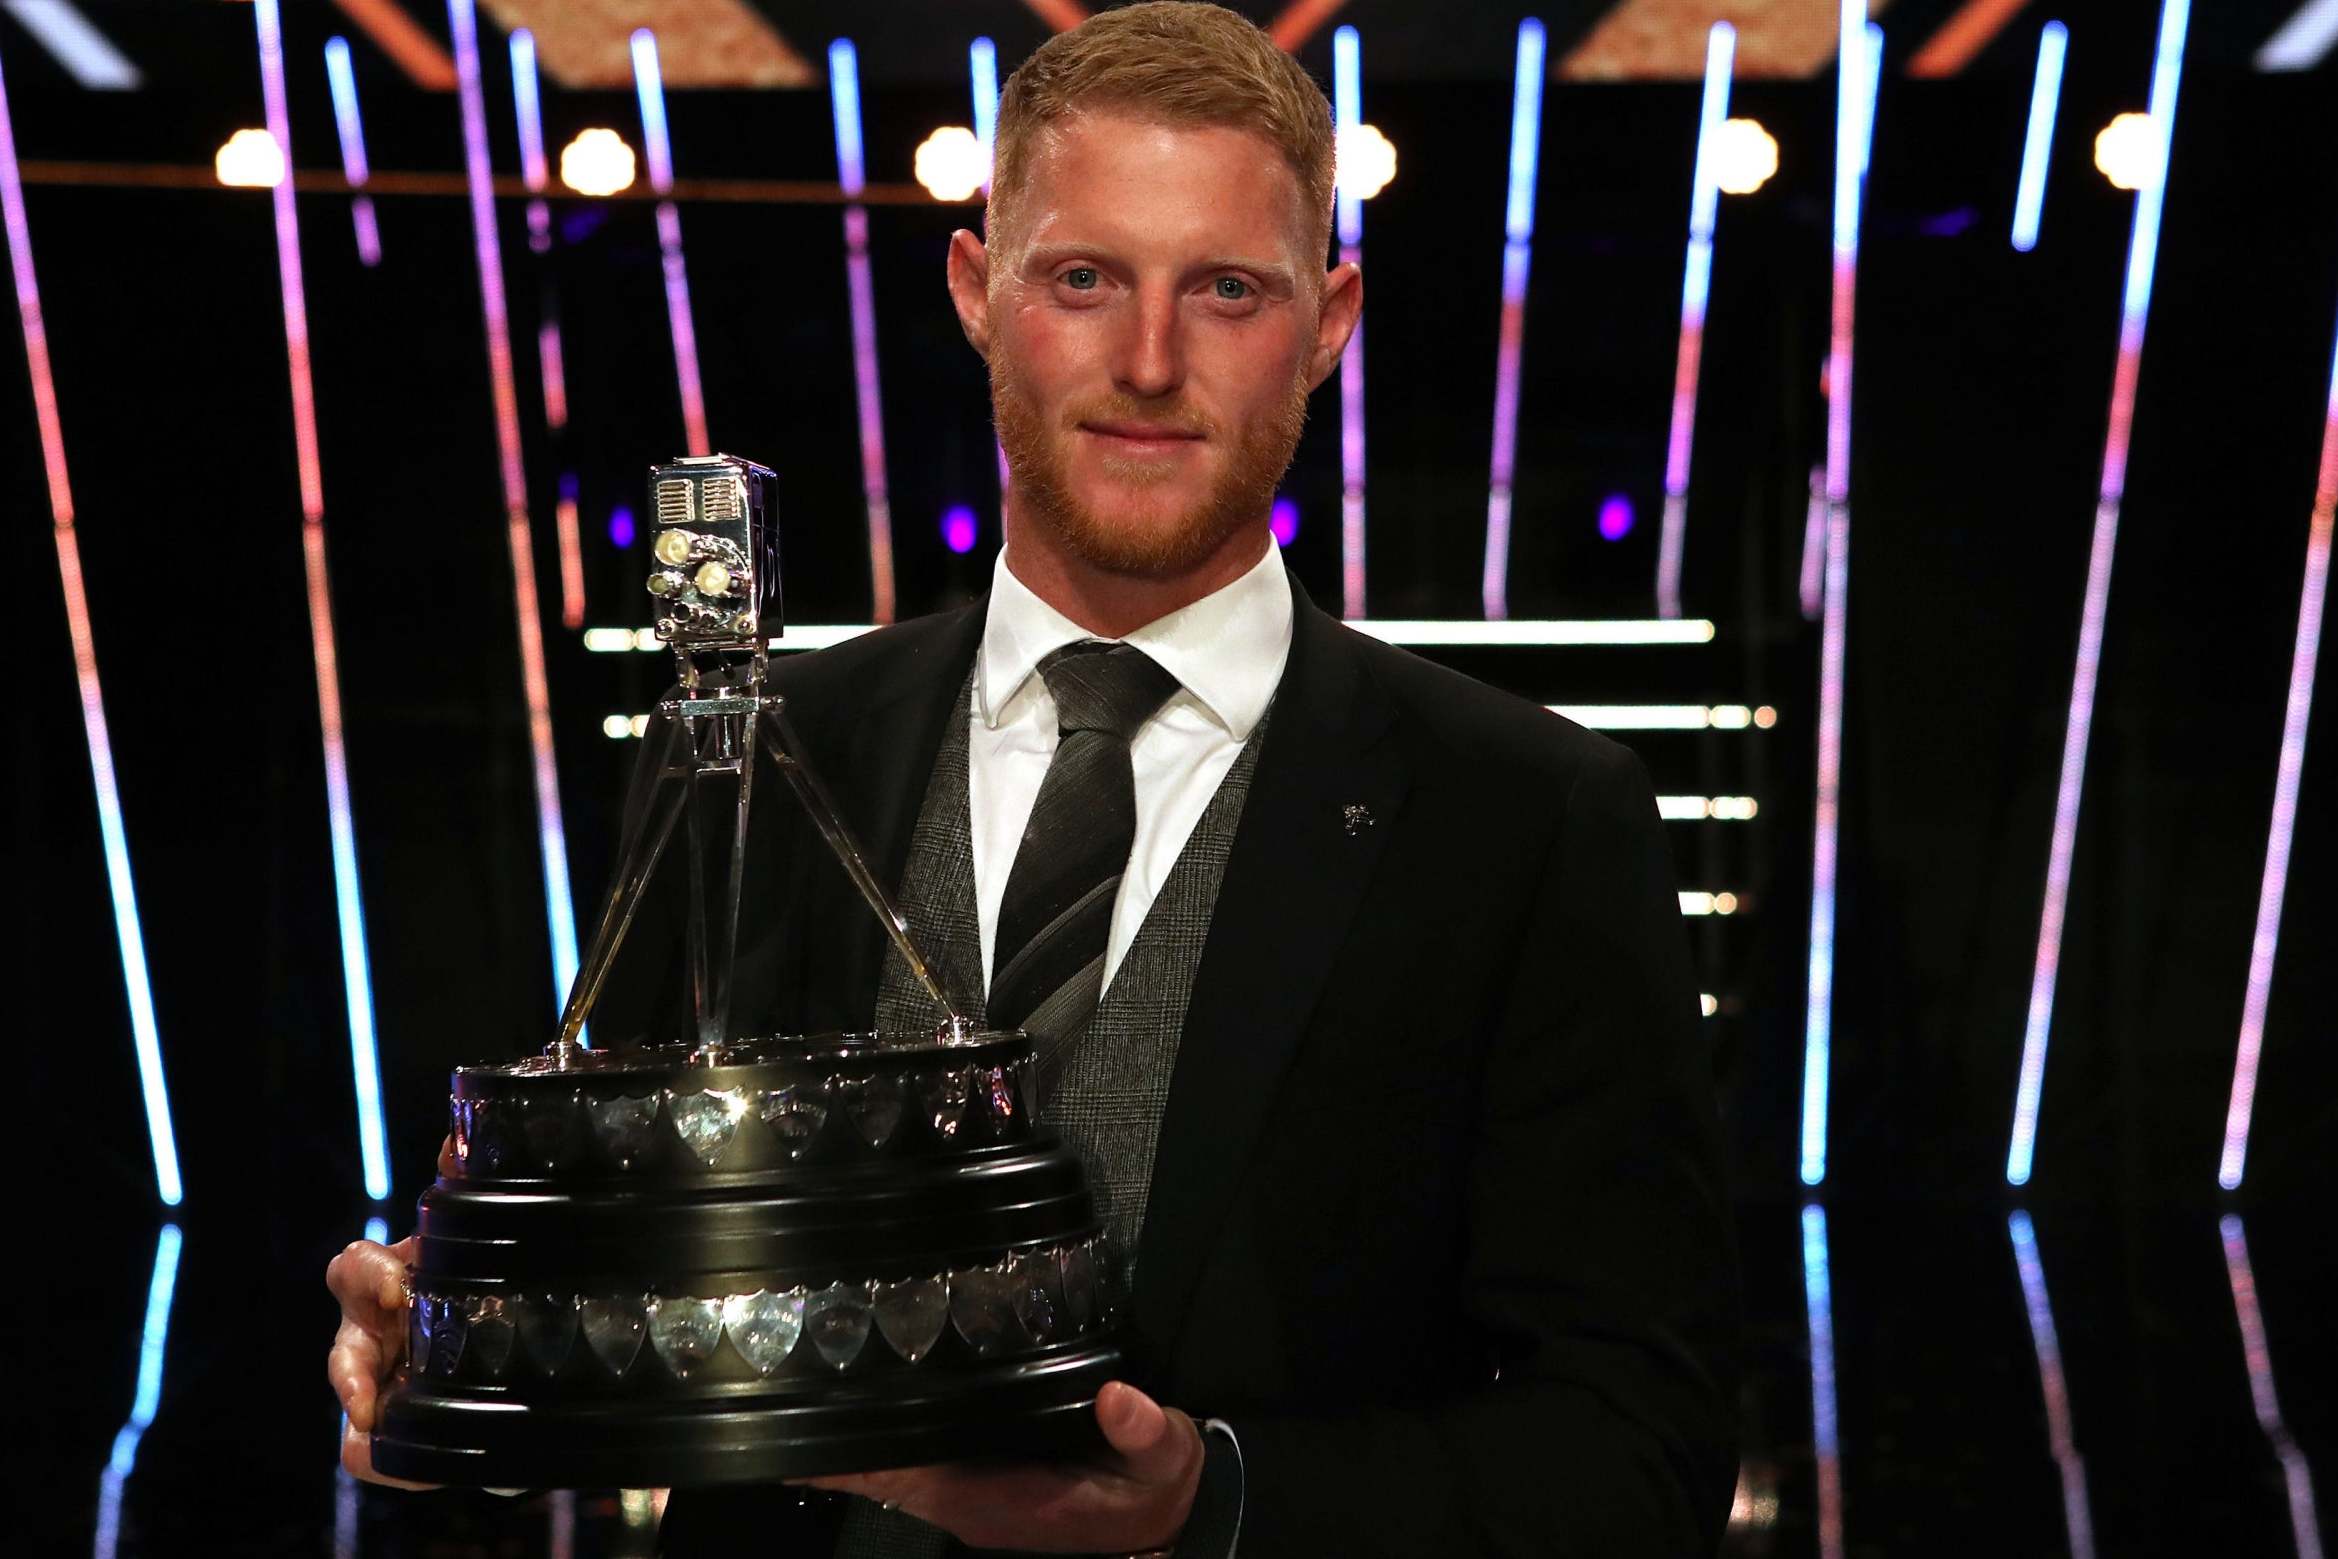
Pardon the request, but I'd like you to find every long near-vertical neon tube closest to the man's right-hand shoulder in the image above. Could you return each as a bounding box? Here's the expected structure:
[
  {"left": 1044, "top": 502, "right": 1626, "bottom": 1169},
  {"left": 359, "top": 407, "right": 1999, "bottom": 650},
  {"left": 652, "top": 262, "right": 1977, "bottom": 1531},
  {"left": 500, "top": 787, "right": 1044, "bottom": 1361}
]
[{"left": 1803, "top": 0, "right": 1882, "bottom": 1185}]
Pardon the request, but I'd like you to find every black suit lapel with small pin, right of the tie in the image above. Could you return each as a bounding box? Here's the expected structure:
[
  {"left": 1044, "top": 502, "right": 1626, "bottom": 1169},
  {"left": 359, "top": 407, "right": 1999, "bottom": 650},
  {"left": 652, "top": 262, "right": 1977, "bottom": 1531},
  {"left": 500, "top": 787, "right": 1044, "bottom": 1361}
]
[{"left": 1136, "top": 580, "right": 1407, "bottom": 1356}]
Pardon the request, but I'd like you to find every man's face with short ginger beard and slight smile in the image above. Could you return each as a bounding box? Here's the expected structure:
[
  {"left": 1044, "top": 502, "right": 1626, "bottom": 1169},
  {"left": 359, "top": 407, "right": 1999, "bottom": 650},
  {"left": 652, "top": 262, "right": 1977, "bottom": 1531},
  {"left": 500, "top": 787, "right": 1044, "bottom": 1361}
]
[{"left": 961, "top": 115, "right": 1347, "bottom": 577}]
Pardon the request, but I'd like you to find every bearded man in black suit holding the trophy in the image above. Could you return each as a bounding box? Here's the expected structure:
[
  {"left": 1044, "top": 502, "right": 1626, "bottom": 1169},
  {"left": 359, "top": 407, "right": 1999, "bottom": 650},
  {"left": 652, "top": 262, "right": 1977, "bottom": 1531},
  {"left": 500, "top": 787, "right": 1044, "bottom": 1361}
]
[{"left": 332, "top": 2, "right": 1735, "bottom": 1559}]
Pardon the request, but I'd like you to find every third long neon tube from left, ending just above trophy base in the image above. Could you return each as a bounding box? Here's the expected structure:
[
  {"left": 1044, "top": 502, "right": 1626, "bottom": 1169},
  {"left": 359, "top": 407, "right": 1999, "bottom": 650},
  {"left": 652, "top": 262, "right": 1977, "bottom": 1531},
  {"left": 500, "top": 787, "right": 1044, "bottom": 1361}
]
[{"left": 446, "top": 0, "right": 577, "bottom": 1037}]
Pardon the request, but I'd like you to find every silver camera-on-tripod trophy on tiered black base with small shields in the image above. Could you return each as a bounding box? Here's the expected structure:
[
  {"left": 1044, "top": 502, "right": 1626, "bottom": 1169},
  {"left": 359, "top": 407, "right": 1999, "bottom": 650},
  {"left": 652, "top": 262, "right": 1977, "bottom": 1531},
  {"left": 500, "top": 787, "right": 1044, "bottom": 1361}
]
[{"left": 374, "top": 456, "right": 1120, "bottom": 1487}]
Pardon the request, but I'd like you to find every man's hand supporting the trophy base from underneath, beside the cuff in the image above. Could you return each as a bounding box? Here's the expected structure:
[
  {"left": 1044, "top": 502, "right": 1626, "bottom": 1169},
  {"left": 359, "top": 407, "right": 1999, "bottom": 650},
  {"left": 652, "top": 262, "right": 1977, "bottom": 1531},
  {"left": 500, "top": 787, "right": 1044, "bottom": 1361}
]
[{"left": 804, "top": 1381, "right": 1202, "bottom": 1554}]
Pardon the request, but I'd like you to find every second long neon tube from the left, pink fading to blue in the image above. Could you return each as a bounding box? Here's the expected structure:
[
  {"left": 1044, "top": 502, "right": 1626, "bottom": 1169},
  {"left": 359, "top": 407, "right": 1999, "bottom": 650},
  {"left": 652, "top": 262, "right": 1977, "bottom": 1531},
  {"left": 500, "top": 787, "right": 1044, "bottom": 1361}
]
[{"left": 253, "top": 0, "right": 390, "bottom": 1201}]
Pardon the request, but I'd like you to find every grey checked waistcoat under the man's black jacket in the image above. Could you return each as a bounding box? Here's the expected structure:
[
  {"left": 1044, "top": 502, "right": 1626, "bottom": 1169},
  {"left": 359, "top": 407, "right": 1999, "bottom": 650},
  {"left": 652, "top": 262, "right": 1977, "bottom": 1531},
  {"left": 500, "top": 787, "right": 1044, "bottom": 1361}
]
[{"left": 837, "top": 678, "right": 1272, "bottom": 1559}]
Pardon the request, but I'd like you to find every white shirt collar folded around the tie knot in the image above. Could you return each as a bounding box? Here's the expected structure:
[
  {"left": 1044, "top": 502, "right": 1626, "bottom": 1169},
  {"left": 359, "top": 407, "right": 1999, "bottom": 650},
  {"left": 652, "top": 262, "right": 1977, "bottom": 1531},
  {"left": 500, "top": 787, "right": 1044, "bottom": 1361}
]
[{"left": 975, "top": 545, "right": 1291, "bottom": 741}]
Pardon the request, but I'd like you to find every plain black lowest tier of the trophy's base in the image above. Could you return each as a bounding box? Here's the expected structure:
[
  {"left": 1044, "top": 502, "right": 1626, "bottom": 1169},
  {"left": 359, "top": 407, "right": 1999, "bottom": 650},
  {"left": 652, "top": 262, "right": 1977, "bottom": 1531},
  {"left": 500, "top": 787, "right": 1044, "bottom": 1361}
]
[{"left": 374, "top": 1342, "right": 1120, "bottom": 1489}]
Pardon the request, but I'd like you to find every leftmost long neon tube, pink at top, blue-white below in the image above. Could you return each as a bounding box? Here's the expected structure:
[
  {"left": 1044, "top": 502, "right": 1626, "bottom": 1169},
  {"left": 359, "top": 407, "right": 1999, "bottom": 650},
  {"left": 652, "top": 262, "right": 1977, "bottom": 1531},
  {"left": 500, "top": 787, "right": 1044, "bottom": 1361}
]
[{"left": 0, "top": 39, "right": 185, "bottom": 1206}]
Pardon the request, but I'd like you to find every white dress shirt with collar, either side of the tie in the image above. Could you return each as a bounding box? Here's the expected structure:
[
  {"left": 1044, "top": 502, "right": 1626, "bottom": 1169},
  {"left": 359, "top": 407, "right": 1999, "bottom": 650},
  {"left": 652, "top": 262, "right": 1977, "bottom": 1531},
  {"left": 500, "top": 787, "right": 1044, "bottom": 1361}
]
[{"left": 968, "top": 542, "right": 1291, "bottom": 989}]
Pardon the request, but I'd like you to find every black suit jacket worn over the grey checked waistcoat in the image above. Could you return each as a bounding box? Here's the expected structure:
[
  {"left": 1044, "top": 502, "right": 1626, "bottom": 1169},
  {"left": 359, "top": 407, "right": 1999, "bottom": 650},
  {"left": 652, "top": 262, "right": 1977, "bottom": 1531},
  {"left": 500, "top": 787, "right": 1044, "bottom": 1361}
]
[{"left": 621, "top": 587, "right": 1737, "bottom": 1559}]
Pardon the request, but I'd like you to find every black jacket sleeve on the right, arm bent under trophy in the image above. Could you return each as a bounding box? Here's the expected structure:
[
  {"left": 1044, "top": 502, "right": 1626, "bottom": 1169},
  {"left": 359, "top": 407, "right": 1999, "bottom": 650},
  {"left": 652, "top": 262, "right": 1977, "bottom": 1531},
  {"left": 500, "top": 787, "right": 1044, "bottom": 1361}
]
[{"left": 1188, "top": 743, "right": 1737, "bottom": 1559}]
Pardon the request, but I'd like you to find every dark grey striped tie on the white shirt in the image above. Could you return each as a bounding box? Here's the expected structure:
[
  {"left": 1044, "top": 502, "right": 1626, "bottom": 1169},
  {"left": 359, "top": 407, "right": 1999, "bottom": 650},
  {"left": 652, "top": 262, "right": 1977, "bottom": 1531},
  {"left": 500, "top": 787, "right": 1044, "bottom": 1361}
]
[{"left": 989, "top": 640, "right": 1178, "bottom": 1096}]
